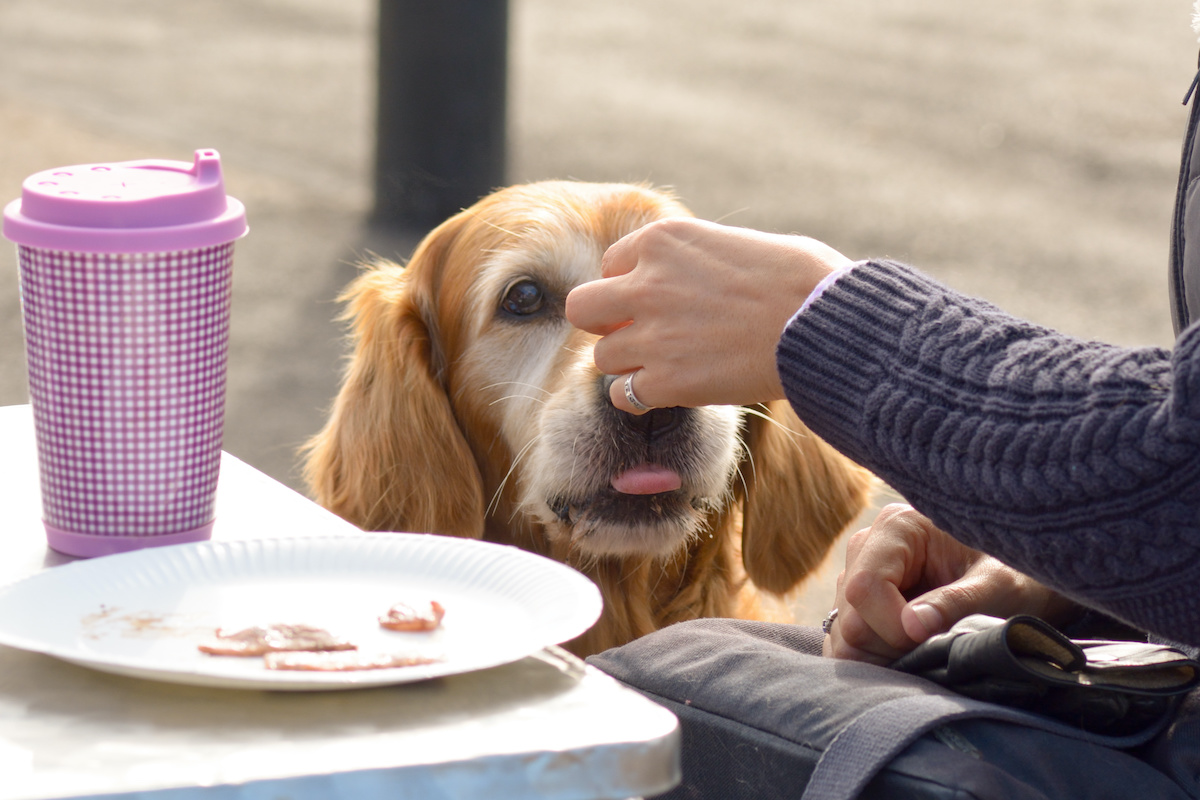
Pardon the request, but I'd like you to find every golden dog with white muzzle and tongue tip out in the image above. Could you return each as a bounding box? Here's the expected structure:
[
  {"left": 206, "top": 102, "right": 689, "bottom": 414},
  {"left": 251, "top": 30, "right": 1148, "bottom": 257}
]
[{"left": 305, "top": 181, "right": 872, "bottom": 655}]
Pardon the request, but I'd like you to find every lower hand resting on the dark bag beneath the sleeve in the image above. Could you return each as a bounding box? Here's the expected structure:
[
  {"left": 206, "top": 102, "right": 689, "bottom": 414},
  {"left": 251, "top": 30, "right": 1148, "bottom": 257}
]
[{"left": 823, "top": 504, "right": 1080, "bottom": 664}]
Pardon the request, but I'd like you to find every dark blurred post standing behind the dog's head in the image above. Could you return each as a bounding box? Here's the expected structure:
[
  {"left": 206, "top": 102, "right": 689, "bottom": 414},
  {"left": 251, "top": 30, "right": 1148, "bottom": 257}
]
[{"left": 372, "top": 0, "right": 509, "bottom": 230}]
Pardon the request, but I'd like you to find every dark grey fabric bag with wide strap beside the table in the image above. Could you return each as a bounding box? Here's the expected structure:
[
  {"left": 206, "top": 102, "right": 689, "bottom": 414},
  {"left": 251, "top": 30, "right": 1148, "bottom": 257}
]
[{"left": 588, "top": 619, "right": 1189, "bottom": 800}]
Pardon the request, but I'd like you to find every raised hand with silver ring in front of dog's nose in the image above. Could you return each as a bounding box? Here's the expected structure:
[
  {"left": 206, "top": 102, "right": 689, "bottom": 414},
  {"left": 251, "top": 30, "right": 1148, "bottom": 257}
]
[{"left": 566, "top": 217, "right": 850, "bottom": 414}]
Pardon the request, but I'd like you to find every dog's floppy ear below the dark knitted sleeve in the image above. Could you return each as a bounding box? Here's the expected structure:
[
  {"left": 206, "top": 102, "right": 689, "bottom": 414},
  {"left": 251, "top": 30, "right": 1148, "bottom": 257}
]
[{"left": 742, "top": 401, "right": 874, "bottom": 594}]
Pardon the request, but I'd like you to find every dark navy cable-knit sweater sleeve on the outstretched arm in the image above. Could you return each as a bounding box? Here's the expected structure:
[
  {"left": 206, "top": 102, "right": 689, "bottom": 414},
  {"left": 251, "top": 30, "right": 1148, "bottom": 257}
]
[{"left": 778, "top": 261, "right": 1200, "bottom": 644}]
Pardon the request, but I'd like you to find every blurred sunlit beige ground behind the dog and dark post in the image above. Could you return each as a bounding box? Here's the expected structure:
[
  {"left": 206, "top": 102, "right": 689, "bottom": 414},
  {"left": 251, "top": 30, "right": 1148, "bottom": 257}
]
[{"left": 0, "top": 0, "right": 1196, "bottom": 619}]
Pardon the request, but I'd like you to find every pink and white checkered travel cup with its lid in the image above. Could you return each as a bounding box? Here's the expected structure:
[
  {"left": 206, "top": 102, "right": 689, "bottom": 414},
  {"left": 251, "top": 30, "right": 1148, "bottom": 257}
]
[{"left": 4, "top": 150, "right": 247, "bottom": 557}]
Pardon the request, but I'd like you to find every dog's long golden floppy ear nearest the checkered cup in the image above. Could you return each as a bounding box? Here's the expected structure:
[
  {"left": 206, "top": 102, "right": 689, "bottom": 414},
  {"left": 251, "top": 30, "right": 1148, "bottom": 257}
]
[{"left": 305, "top": 224, "right": 484, "bottom": 539}]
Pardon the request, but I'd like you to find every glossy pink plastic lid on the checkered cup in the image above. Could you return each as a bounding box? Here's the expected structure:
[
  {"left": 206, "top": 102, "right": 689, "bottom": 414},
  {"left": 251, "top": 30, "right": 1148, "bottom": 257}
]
[{"left": 4, "top": 150, "right": 247, "bottom": 253}]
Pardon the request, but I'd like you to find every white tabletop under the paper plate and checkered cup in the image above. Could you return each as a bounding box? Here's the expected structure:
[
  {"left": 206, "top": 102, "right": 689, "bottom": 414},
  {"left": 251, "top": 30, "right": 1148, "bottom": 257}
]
[{"left": 0, "top": 405, "right": 679, "bottom": 800}]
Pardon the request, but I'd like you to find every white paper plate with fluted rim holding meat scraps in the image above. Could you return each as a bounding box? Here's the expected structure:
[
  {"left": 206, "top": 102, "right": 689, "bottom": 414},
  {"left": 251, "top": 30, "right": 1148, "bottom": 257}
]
[{"left": 0, "top": 534, "right": 601, "bottom": 691}]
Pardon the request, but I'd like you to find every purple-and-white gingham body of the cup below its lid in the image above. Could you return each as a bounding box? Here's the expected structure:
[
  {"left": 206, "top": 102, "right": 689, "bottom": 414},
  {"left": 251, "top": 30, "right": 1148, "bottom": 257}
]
[{"left": 18, "top": 242, "right": 233, "bottom": 536}]
